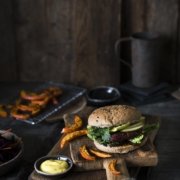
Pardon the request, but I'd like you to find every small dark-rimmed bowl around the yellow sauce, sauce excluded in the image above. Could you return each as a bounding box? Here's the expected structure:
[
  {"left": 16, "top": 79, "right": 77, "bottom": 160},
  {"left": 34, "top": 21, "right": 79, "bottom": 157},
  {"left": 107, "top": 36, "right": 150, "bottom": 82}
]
[{"left": 34, "top": 155, "right": 73, "bottom": 177}]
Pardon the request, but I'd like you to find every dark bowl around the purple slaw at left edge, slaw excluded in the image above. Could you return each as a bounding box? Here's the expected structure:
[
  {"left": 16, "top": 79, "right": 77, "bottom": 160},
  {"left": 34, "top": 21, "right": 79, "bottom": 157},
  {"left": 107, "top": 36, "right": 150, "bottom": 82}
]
[{"left": 0, "top": 130, "right": 24, "bottom": 176}]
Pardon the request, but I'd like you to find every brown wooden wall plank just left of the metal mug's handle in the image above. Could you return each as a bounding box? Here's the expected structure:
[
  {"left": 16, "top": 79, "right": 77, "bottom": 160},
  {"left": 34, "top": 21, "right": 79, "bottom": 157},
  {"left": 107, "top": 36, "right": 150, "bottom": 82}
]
[{"left": 71, "top": 0, "right": 121, "bottom": 86}]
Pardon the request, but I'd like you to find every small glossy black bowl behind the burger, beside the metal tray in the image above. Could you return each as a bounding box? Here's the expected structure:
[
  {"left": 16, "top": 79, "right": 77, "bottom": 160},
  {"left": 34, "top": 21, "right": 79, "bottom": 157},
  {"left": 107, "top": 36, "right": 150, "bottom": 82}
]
[{"left": 87, "top": 86, "right": 121, "bottom": 106}]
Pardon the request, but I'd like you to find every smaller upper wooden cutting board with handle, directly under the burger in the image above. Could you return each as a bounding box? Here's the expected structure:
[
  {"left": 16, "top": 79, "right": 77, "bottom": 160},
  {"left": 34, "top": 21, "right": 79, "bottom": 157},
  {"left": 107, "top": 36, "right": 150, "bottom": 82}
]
[{"left": 64, "top": 107, "right": 160, "bottom": 180}]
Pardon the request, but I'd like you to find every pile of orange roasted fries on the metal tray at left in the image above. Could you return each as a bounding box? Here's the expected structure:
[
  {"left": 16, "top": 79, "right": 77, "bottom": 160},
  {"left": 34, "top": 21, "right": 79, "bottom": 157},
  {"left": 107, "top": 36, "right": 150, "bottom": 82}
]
[{"left": 0, "top": 87, "right": 63, "bottom": 120}]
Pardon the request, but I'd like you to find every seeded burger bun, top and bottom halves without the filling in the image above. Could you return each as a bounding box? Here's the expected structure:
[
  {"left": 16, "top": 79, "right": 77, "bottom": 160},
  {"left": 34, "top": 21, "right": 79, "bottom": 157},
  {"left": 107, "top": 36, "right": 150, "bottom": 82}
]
[{"left": 88, "top": 105, "right": 147, "bottom": 154}]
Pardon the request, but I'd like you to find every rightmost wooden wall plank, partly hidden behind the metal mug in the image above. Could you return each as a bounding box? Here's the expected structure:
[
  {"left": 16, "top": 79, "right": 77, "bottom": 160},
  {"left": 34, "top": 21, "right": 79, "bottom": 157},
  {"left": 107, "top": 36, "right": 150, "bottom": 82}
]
[{"left": 146, "top": 0, "right": 179, "bottom": 82}]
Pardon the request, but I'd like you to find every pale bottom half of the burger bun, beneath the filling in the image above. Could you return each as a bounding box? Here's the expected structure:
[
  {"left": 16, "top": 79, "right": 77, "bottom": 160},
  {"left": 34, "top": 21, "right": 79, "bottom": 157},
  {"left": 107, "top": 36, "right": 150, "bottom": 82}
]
[{"left": 94, "top": 137, "right": 147, "bottom": 154}]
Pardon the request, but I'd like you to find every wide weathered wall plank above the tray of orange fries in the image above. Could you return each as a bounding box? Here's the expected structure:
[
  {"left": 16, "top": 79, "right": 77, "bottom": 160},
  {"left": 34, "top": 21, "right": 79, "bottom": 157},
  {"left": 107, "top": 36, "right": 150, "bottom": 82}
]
[{"left": 15, "top": 0, "right": 72, "bottom": 82}]
